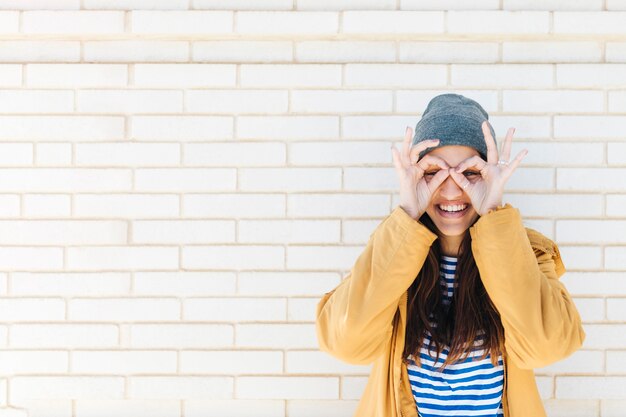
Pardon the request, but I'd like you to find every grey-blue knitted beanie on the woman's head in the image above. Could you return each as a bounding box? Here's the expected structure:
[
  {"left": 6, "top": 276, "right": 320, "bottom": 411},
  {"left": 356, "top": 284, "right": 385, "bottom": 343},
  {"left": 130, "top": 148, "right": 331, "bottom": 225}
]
[{"left": 412, "top": 94, "right": 496, "bottom": 160}]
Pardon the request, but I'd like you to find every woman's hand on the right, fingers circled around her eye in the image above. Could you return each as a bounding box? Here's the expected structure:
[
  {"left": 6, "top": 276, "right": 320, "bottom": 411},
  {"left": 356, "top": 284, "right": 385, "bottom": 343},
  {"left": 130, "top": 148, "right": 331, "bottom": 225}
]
[{"left": 450, "top": 121, "right": 528, "bottom": 216}]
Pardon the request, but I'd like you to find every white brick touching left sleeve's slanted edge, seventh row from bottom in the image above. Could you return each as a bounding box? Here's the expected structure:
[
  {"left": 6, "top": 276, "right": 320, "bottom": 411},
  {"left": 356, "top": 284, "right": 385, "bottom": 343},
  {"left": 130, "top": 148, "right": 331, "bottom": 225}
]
[{"left": 287, "top": 246, "right": 363, "bottom": 269}]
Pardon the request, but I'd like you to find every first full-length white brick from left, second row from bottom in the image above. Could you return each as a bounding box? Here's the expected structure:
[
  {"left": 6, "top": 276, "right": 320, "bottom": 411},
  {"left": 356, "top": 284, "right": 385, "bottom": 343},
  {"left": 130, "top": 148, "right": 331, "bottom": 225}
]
[{"left": 11, "top": 376, "right": 124, "bottom": 401}]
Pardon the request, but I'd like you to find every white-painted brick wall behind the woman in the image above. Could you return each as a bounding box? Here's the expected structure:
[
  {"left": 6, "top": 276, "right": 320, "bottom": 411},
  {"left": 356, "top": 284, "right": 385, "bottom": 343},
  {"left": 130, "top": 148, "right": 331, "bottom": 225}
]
[{"left": 0, "top": 0, "right": 626, "bottom": 417}]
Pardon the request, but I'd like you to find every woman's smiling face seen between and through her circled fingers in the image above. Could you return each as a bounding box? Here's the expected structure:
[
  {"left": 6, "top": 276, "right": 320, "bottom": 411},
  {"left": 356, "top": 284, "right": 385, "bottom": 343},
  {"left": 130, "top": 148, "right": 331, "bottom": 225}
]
[{"left": 424, "top": 145, "right": 482, "bottom": 237}]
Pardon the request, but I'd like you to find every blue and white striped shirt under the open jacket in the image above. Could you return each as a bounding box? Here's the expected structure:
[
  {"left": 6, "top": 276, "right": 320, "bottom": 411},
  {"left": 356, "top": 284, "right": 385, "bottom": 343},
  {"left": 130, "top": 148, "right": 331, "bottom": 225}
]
[{"left": 407, "top": 256, "right": 504, "bottom": 417}]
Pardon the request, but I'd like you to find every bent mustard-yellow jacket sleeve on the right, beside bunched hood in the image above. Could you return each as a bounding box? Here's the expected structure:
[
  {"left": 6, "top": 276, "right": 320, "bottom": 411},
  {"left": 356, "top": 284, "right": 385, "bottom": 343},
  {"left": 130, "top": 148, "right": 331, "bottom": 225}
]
[{"left": 470, "top": 204, "right": 585, "bottom": 369}]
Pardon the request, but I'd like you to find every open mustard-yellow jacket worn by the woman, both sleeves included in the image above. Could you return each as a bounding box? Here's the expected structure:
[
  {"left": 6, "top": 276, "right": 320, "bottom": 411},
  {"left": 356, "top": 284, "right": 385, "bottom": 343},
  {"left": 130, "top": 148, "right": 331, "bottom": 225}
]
[{"left": 316, "top": 204, "right": 585, "bottom": 417}]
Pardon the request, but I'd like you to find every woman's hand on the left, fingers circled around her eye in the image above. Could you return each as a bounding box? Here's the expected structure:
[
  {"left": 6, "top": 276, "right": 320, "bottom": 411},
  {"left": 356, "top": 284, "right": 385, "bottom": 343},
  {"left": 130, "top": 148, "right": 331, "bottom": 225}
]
[{"left": 391, "top": 127, "right": 450, "bottom": 220}]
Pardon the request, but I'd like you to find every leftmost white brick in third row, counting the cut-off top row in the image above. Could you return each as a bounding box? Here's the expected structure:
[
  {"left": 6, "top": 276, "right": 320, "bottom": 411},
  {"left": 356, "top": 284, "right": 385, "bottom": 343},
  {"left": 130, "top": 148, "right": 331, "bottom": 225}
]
[{"left": 0, "top": 40, "right": 80, "bottom": 63}]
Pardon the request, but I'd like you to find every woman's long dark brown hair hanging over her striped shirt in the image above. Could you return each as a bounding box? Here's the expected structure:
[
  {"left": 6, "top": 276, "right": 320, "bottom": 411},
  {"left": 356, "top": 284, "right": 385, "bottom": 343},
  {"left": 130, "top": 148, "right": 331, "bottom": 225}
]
[{"left": 403, "top": 213, "right": 506, "bottom": 370}]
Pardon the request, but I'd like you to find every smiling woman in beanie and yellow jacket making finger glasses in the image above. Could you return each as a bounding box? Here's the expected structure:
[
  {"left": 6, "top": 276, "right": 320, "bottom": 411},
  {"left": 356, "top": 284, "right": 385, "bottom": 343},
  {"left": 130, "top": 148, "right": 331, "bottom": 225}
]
[{"left": 316, "top": 94, "right": 585, "bottom": 417}]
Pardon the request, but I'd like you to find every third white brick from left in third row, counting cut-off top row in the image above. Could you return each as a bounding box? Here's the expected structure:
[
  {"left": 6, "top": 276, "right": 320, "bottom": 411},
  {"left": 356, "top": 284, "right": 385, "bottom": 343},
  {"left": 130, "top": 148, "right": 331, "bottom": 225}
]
[{"left": 191, "top": 40, "right": 293, "bottom": 63}]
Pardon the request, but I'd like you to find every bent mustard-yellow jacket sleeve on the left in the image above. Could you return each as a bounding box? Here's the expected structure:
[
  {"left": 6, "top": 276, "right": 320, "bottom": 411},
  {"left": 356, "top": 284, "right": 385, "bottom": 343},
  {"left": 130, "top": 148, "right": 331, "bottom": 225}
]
[{"left": 316, "top": 206, "right": 437, "bottom": 364}]
